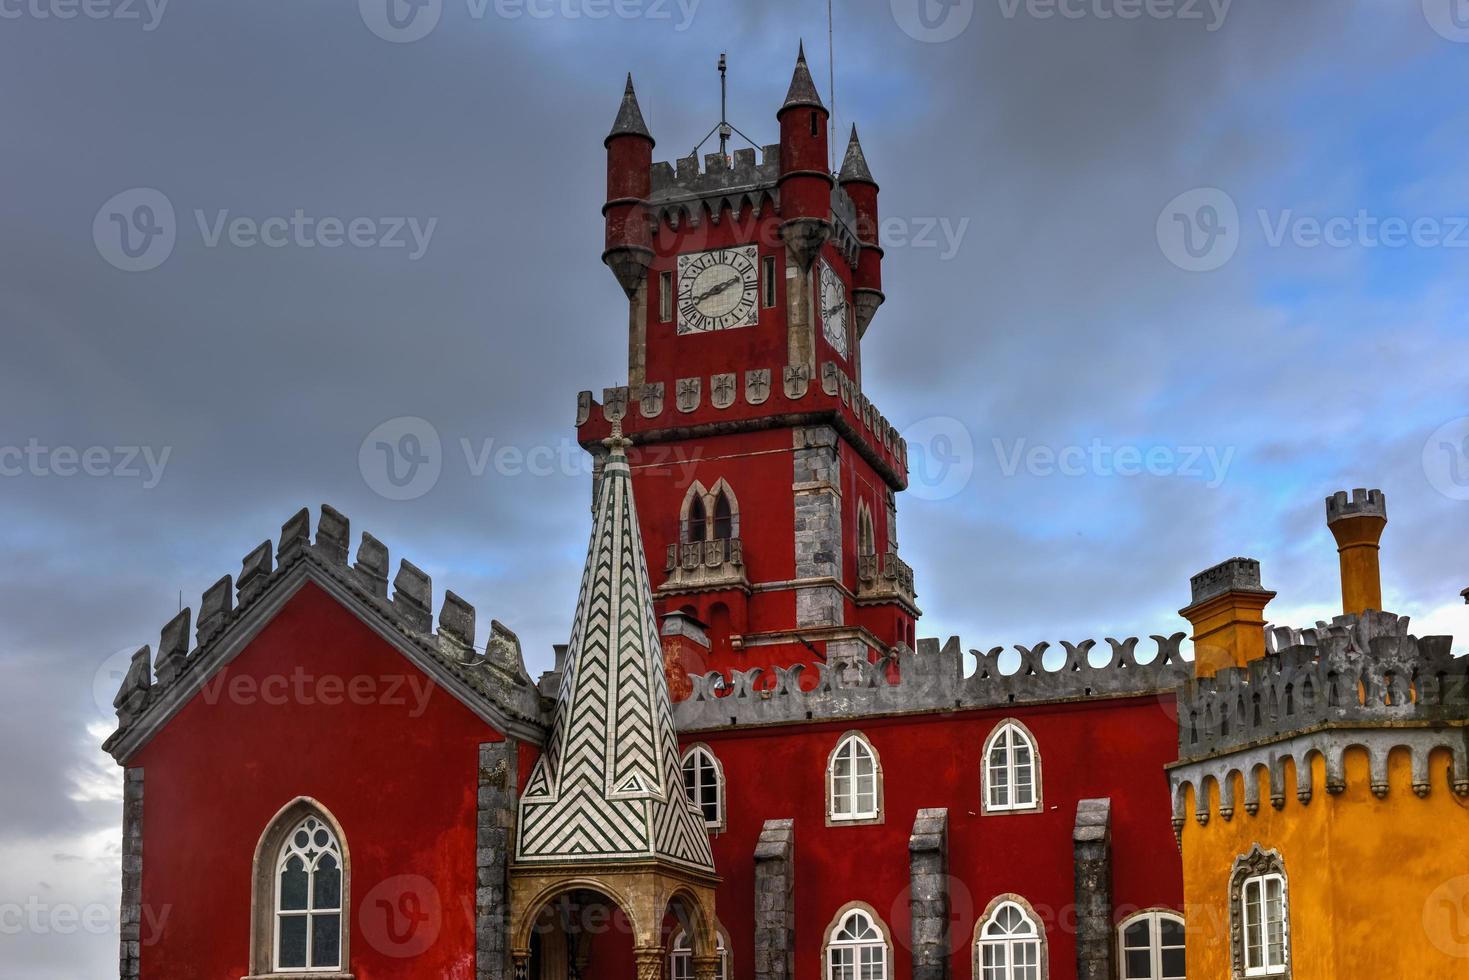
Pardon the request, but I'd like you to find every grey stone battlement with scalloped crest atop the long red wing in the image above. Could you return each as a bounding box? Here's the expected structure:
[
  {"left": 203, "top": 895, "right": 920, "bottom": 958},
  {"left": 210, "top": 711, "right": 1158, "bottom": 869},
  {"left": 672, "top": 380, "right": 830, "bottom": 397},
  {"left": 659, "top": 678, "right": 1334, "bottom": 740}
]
[{"left": 674, "top": 633, "right": 1190, "bottom": 732}]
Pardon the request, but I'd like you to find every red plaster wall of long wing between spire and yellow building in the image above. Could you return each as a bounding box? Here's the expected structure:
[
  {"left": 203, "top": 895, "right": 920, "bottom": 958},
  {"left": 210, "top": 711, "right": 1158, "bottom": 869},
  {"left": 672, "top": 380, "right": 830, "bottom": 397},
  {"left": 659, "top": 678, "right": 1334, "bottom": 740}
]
[{"left": 685, "top": 698, "right": 1183, "bottom": 980}]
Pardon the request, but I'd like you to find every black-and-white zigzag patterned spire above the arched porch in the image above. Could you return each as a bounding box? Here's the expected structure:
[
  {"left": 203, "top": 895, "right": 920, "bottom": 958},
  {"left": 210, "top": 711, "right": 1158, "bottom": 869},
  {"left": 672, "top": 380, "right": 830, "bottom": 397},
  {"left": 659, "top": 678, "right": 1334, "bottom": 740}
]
[{"left": 516, "top": 428, "right": 714, "bottom": 871}]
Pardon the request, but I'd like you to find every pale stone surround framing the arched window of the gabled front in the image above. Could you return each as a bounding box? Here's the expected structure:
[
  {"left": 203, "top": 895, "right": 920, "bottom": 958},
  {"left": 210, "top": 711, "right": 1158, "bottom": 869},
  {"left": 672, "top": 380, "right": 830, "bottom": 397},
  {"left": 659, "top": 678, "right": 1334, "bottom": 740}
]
[{"left": 242, "top": 796, "right": 354, "bottom": 980}]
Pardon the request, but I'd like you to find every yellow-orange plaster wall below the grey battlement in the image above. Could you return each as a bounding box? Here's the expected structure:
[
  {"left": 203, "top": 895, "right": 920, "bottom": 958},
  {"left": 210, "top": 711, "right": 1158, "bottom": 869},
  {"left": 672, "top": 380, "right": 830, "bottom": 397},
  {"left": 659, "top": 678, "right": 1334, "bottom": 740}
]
[{"left": 1183, "top": 749, "right": 1469, "bottom": 980}]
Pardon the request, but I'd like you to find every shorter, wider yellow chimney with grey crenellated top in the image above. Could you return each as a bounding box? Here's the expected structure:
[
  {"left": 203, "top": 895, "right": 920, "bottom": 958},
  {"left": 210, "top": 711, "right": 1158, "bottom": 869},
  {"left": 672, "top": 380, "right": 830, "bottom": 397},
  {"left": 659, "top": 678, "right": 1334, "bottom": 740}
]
[{"left": 1178, "top": 558, "right": 1275, "bottom": 677}]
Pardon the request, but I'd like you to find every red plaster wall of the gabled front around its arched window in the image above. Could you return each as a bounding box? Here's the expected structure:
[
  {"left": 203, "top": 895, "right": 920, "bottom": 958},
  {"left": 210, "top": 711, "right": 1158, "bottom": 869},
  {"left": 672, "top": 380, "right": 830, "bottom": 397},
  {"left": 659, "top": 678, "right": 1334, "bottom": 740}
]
[{"left": 132, "top": 583, "right": 501, "bottom": 980}]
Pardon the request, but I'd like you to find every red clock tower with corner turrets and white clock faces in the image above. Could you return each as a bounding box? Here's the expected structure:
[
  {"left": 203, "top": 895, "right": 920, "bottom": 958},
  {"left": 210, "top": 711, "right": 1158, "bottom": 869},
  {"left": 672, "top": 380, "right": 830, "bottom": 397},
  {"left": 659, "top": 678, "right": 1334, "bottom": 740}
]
[{"left": 577, "top": 51, "right": 920, "bottom": 681}]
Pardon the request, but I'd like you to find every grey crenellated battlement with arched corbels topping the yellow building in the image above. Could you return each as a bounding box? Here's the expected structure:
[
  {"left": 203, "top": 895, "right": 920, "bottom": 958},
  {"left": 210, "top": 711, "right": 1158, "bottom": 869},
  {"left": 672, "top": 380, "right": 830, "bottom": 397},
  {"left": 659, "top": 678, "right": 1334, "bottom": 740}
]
[{"left": 1171, "top": 610, "right": 1469, "bottom": 830}]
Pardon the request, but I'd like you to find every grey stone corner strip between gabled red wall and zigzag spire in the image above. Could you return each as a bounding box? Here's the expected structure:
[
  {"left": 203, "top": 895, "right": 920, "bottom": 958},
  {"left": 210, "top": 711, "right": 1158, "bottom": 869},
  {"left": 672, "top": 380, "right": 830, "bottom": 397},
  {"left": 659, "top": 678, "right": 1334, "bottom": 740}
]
[{"left": 474, "top": 739, "right": 517, "bottom": 980}]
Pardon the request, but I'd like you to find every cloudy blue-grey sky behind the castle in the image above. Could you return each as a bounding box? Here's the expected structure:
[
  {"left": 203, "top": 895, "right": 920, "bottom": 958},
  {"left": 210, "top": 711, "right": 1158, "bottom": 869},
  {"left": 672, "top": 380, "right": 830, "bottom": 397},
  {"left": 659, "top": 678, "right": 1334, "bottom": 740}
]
[{"left": 0, "top": 0, "right": 1469, "bottom": 979}]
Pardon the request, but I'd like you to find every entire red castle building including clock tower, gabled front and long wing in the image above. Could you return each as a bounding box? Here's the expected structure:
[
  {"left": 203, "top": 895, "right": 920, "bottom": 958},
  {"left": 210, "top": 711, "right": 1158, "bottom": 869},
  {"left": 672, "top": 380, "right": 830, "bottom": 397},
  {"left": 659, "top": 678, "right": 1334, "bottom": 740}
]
[{"left": 107, "top": 47, "right": 1188, "bottom": 980}]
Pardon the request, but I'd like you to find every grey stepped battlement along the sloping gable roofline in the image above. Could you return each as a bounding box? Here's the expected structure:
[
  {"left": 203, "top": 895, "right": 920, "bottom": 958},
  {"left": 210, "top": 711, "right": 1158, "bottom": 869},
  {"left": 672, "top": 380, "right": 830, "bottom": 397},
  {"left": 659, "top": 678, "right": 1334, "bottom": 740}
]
[{"left": 103, "top": 504, "right": 541, "bottom": 761}]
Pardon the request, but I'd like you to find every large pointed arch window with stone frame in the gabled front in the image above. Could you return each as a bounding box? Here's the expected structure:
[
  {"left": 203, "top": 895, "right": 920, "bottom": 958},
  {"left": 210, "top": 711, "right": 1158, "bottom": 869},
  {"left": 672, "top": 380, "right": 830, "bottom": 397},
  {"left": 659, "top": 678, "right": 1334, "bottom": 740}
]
[{"left": 250, "top": 798, "right": 351, "bottom": 977}]
